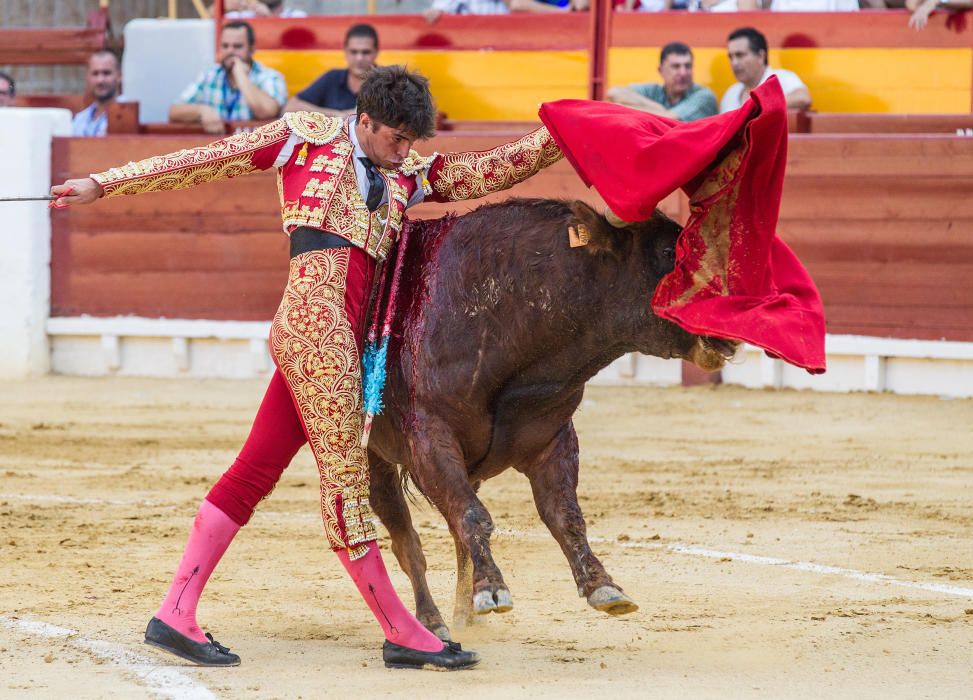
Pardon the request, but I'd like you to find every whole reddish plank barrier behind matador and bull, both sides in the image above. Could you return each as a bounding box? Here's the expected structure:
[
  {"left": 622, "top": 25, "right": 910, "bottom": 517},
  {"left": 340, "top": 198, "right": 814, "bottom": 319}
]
[{"left": 51, "top": 131, "right": 973, "bottom": 341}]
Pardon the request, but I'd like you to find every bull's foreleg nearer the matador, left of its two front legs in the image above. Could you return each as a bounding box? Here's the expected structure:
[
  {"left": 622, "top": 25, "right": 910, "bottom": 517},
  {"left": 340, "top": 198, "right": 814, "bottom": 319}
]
[{"left": 409, "top": 412, "right": 513, "bottom": 615}]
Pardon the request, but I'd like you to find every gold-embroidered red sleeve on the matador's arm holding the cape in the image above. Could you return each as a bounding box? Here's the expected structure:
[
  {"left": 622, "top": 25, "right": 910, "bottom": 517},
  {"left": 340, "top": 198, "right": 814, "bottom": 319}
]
[{"left": 426, "top": 126, "right": 563, "bottom": 202}]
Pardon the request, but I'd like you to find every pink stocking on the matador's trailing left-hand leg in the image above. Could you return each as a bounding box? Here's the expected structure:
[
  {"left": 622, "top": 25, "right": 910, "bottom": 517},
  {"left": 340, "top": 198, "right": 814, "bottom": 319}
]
[{"left": 155, "top": 500, "right": 240, "bottom": 642}]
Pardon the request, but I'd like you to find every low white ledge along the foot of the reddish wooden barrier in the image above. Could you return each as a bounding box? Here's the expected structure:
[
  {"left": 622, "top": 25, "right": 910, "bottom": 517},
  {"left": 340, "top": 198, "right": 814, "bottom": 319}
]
[{"left": 47, "top": 317, "right": 973, "bottom": 397}]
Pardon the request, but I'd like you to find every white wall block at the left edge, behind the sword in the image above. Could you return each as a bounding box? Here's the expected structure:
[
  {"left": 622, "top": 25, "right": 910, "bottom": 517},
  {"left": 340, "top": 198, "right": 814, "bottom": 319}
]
[{"left": 0, "top": 108, "right": 71, "bottom": 377}]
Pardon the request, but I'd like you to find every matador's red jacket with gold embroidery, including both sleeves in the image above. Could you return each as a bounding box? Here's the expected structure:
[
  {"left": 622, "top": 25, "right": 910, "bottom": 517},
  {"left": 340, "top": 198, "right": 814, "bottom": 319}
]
[{"left": 91, "top": 112, "right": 562, "bottom": 259}]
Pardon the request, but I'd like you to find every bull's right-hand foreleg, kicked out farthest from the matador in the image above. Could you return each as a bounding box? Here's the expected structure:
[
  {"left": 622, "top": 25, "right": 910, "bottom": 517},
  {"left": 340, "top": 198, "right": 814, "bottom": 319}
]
[{"left": 524, "top": 421, "right": 638, "bottom": 615}]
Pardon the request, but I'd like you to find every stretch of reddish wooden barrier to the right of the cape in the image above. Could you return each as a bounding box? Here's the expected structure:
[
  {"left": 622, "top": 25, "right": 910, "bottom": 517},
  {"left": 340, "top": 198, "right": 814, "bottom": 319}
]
[{"left": 778, "top": 135, "right": 973, "bottom": 341}]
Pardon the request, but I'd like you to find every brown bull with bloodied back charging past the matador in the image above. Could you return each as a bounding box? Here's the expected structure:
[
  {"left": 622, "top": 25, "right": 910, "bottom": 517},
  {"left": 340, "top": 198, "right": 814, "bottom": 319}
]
[{"left": 368, "top": 199, "right": 732, "bottom": 639}]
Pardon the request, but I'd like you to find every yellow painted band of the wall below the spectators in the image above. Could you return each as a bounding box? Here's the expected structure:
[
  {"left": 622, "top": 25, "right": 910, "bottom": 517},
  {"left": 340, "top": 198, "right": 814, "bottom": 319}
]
[{"left": 257, "top": 47, "right": 973, "bottom": 120}]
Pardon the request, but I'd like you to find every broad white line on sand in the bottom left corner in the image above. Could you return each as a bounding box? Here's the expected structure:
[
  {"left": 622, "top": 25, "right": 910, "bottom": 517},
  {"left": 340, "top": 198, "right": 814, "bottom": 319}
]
[{"left": 0, "top": 615, "right": 216, "bottom": 700}]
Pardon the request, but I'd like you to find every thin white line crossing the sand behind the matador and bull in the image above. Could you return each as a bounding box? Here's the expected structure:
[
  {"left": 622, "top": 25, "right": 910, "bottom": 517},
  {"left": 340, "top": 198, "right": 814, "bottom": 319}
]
[{"left": 9, "top": 494, "right": 973, "bottom": 600}]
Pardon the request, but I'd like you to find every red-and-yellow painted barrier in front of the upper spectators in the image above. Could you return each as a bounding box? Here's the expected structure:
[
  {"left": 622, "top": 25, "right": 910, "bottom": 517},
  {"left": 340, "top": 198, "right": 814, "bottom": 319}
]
[{"left": 253, "top": 10, "right": 973, "bottom": 121}]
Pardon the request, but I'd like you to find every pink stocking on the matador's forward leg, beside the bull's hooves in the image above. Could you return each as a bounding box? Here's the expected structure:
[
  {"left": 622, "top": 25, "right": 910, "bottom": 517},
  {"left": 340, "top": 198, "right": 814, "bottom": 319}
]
[{"left": 335, "top": 542, "right": 443, "bottom": 651}]
